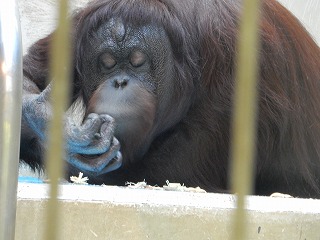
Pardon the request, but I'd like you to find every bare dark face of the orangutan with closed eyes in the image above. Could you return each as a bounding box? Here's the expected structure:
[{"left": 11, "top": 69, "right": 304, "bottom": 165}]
[{"left": 82, "top": 20, "right": 160, "bottom": 165}]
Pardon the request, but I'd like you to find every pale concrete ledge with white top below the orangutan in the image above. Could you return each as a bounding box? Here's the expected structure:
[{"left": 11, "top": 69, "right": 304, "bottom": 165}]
[{"left": 16, "top": 183, "right": 320, "bottom": 240}]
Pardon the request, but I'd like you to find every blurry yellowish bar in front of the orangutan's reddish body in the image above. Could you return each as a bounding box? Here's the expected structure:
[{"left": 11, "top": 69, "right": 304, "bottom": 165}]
[{"left": 231, "top": 0, "right": 260, "bottom": 240}]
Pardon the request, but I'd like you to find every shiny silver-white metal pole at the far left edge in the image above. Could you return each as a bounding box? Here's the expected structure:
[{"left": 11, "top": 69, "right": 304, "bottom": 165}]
[{"left": 0, "top": 0, "right": 22, "bottom": 240}]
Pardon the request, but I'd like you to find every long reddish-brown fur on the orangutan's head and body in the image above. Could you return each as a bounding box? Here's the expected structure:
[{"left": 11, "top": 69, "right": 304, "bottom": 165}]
[{"left": 21, "top": 0, "right": 320, "bottom": 197}]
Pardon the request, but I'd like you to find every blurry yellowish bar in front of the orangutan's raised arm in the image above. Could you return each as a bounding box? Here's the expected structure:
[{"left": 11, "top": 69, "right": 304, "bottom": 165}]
[{"left": 44, "top": 0, "right": 71, "bottom": 240}]
